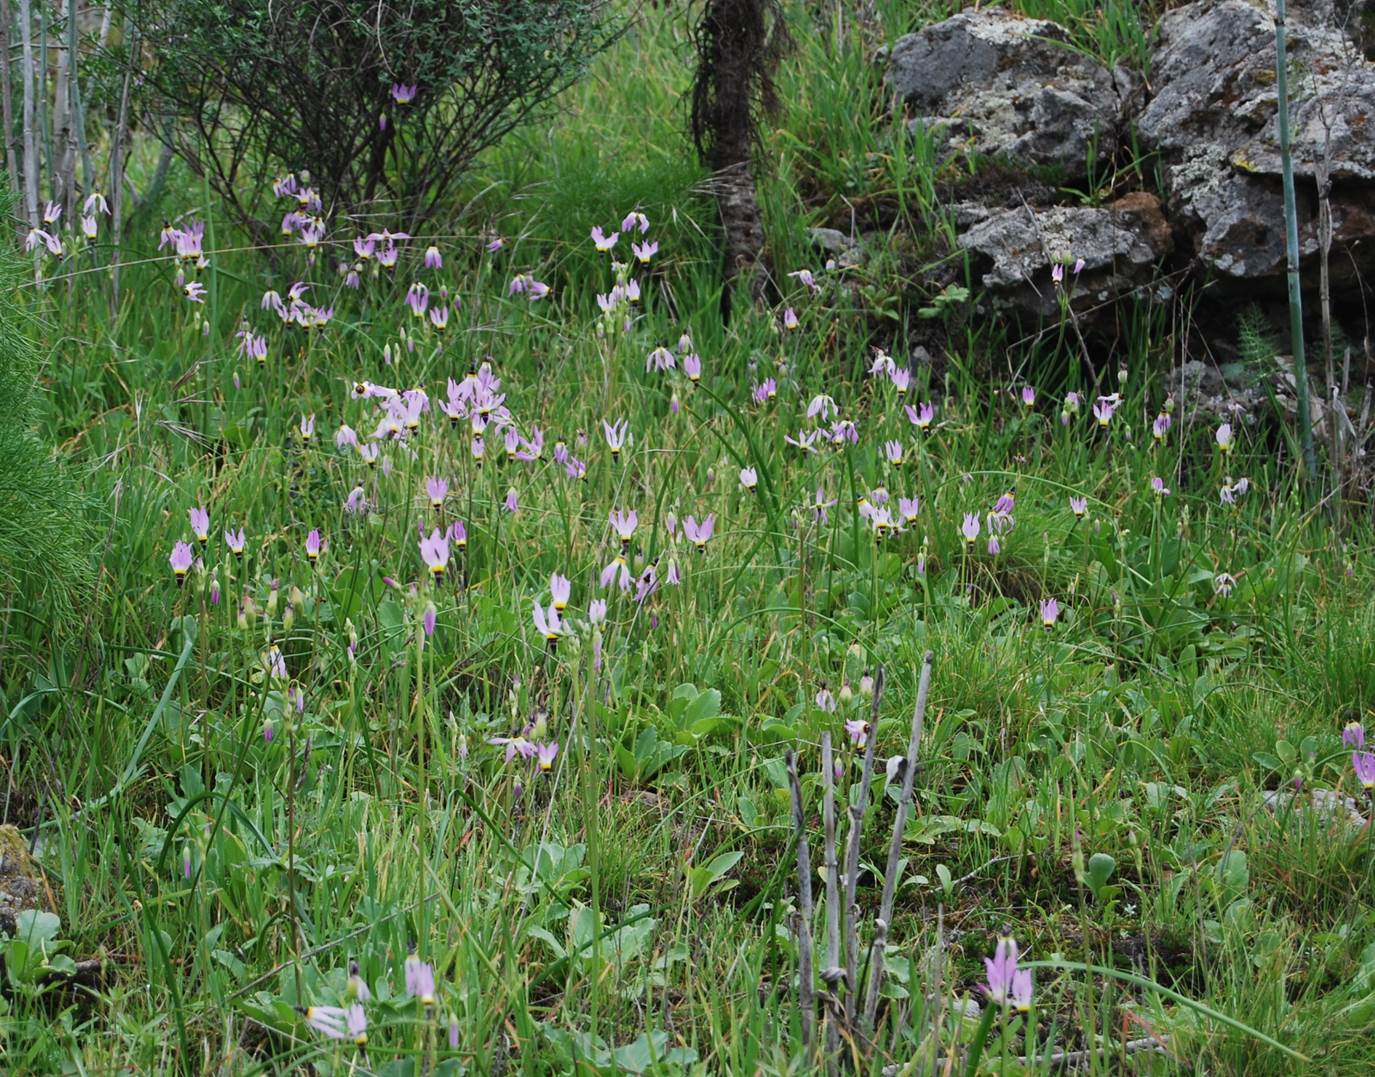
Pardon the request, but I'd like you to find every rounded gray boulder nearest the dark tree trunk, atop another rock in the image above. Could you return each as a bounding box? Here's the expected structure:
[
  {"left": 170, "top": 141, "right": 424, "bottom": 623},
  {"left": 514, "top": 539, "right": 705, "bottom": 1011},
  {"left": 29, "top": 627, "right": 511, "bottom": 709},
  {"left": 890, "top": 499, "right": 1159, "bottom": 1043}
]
[{"left": 886, "top": 7, "right": 1133, "bottom": 179}]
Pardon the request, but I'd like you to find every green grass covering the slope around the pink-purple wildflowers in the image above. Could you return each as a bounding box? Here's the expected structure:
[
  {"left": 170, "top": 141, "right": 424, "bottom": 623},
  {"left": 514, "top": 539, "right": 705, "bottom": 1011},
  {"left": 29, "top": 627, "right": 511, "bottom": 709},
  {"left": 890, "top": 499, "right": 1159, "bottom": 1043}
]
[{"left": 0, "top": 6, "right": 1375, "bottom": 1074}]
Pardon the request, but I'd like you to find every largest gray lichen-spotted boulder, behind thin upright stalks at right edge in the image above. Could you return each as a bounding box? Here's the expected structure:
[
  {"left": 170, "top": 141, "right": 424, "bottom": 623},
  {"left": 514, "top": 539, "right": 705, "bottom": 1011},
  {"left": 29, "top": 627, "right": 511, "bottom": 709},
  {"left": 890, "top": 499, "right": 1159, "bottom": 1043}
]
[{"left": 1137, "top": 0, "right": 1375, "bottom": 294}]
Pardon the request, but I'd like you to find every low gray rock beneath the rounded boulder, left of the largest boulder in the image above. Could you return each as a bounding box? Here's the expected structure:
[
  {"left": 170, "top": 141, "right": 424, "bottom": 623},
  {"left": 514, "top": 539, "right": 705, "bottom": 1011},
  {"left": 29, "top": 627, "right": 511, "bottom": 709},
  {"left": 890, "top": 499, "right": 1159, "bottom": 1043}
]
[{"left": 957, "top": 193, "right": 1172, "bottom": 318}]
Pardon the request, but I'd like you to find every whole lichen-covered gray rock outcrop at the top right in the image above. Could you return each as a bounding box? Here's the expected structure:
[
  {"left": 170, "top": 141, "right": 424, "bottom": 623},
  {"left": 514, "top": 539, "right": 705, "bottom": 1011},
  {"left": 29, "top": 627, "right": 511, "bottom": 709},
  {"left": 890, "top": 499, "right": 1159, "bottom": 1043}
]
[{"left": 887, "top": 0, "right": 1375, "bottom": 318}]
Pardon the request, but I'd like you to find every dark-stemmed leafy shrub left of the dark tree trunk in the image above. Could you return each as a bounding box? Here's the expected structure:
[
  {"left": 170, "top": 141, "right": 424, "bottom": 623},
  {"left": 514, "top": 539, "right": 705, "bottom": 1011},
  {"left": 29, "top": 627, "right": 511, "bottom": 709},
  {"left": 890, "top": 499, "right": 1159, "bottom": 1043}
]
[{"left": 131, "top": 0, "right": 619, "bottom": 223}]
